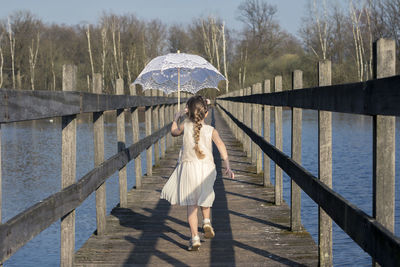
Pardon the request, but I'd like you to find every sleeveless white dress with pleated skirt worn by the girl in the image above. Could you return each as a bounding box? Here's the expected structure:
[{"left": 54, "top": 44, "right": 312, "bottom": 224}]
[{"left": 160, "top": 119, "right": 217, "bottom": 207}]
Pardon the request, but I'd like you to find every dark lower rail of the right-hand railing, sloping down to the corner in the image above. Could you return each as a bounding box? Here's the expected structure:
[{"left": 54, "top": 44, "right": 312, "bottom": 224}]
[{"left": 218, "top": 105, "right": 400, "bottom": 266}]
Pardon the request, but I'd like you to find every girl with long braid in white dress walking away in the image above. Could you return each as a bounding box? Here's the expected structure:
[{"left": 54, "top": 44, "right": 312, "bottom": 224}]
[{"left": 161, "top": 96, "right": 234, "bottom": 251}]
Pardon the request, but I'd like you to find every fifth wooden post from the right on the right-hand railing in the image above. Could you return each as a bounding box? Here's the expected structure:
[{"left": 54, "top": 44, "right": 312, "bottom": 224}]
[{"left": 263, "top": 80, "right": 271, "bottom": 186}]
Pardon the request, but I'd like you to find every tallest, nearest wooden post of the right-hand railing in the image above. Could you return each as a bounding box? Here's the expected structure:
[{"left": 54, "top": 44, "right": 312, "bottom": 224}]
[{"left": 372, "top": 39, "right": 396, "bottom": 266}]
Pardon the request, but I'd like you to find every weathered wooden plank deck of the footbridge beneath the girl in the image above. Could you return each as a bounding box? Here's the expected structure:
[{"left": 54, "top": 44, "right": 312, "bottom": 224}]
[{"left": 75, "top": 110, "right": 318, "bottom": 266}]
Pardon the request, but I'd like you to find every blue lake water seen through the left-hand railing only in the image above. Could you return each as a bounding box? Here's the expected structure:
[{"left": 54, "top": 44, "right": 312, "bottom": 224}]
[{"left": 2, "top": 112, "right": 146, "bottom": 266}]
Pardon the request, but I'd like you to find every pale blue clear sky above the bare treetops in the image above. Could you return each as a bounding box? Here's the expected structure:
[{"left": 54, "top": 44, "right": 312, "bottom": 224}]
[{"left": 0, "top": 0, "right": 307, "bottom": 35}]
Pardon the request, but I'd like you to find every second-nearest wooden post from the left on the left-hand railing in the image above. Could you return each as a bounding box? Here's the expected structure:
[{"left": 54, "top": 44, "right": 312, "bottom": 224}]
[{"left": 93, "top": 73, "right": 106, "bottom": 235}]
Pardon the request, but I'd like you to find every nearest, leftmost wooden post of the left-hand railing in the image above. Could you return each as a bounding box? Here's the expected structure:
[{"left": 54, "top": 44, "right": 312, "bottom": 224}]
[{"left": 60, "top": 65, "right": 77, "bottom": 267}]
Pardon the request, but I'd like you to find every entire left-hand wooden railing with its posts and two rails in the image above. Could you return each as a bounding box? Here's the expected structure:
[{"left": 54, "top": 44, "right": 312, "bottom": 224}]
[{"left": 0, "top": 65, "right": 190, "bottom": 266}]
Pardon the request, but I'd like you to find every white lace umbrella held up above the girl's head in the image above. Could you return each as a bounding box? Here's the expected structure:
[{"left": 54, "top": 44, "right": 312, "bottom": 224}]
[{"left": 133, "top": 51, "right": 226, "bottom": 110}]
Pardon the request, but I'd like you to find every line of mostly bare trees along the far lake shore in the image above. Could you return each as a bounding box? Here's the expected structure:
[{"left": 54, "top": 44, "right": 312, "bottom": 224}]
[{"left": 0, "top": 0, "right": 400, "bottom": 94}]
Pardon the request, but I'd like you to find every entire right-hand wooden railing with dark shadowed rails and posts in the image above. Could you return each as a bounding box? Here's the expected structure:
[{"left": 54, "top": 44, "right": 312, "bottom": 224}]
[{"left": 217, "top": 39, "right": 400, "bottom": 266}]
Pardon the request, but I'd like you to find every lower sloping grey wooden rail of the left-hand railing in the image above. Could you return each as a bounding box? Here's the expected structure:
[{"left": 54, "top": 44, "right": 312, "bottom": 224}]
[{"left": 0, "top": 123, "right": 172, "bottom": 262}]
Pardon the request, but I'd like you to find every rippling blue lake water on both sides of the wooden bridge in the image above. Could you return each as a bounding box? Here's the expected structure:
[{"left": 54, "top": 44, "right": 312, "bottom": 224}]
[{"left": 2, "top": 110, "right": 400, "bottom": 266}]
